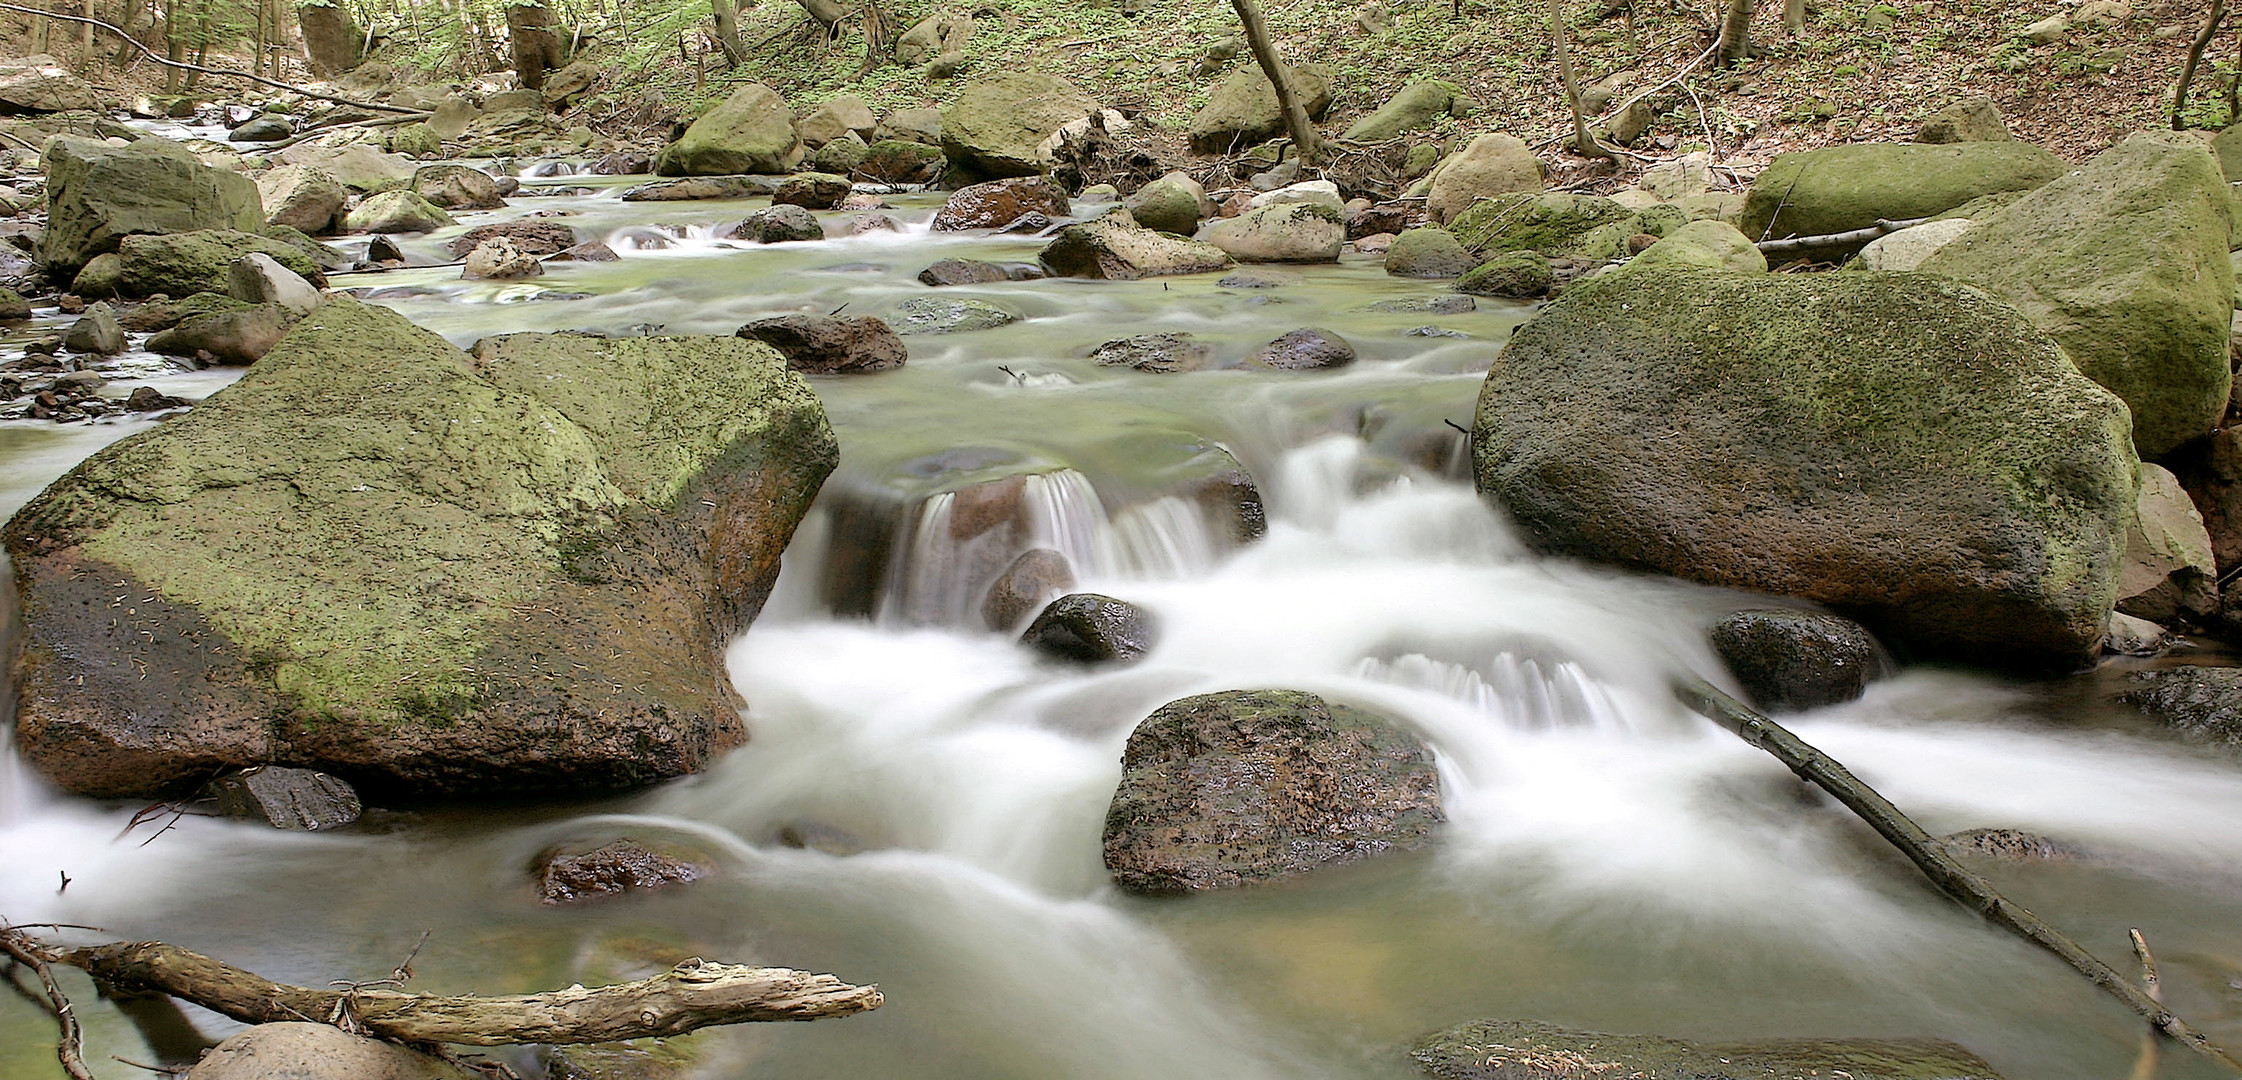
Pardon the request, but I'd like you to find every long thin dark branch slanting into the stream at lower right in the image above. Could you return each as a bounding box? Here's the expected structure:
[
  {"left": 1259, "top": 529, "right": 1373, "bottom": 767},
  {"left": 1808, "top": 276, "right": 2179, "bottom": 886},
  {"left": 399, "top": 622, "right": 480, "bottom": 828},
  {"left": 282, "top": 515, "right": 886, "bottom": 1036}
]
[{"left": 1675, "top": 679, "right": 2242, "bottom": 1073}]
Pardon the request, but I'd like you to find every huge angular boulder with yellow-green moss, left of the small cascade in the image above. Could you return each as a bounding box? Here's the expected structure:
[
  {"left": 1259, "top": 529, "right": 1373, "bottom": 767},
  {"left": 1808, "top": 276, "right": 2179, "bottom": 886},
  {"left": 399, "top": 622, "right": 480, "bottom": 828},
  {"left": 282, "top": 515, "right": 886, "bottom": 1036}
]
[{"left": 0, "top": 298, "right": 836, "bottom": 798}]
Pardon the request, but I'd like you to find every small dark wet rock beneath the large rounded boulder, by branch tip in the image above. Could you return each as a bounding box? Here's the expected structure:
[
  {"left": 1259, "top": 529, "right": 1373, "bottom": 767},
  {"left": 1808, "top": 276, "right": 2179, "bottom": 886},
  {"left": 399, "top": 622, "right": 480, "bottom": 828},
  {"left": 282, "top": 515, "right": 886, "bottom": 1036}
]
[{"left": 1713, "top": 607, "right": 1883, "bottom": 713}]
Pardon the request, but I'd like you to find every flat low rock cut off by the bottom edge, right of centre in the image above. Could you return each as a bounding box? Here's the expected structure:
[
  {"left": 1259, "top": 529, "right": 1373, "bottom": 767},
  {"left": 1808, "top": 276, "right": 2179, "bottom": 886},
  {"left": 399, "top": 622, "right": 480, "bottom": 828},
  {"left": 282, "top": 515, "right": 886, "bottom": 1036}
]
[{"left": 1410, "top": 1020, "right": 2000, "bottom": 1080}]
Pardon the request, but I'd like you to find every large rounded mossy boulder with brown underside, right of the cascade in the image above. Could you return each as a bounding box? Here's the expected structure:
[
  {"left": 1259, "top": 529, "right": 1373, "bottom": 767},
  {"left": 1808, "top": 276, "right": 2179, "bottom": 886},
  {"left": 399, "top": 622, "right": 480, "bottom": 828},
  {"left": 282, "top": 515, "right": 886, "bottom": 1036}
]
[{"left": 1471, "top": 269, "right": 2137, "bottom": 668}]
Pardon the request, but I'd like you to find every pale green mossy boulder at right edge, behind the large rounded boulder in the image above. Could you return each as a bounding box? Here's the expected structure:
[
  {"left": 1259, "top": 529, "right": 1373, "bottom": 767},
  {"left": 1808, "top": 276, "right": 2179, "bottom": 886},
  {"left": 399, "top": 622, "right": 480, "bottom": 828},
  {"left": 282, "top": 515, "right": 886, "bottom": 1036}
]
[{"left": 1919, "top": 132, "right": 2235, "bottom": 457}]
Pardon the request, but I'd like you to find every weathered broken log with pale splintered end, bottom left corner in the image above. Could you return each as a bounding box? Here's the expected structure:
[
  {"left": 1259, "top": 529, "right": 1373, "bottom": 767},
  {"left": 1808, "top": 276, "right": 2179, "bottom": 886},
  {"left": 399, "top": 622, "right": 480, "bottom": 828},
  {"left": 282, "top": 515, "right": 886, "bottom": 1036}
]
[{"left": 45, "top": 941, "right": 881, "bottom": 1046}]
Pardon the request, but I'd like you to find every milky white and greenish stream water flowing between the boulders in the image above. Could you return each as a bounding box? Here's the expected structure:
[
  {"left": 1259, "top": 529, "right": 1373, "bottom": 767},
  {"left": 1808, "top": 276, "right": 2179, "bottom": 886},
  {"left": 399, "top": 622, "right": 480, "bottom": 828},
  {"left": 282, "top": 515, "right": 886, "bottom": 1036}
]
[{"left": 0, "top": 177, "right": 2242, "bottom": 1080}]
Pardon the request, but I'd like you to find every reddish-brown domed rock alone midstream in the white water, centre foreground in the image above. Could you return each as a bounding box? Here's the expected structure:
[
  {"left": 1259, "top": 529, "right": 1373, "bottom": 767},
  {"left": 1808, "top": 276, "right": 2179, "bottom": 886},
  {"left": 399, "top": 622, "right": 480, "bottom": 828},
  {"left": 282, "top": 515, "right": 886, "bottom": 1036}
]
[{"left": 1105, "top": 690, "right": 1444, "bottom": 894}]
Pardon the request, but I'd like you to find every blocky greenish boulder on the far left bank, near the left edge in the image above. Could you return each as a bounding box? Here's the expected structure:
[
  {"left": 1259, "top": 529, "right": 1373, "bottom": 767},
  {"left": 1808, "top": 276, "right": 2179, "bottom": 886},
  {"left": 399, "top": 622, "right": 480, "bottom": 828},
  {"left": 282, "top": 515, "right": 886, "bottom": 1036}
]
[{"left": 38, "top": 139, "right": 265, "bottom": 280}]
